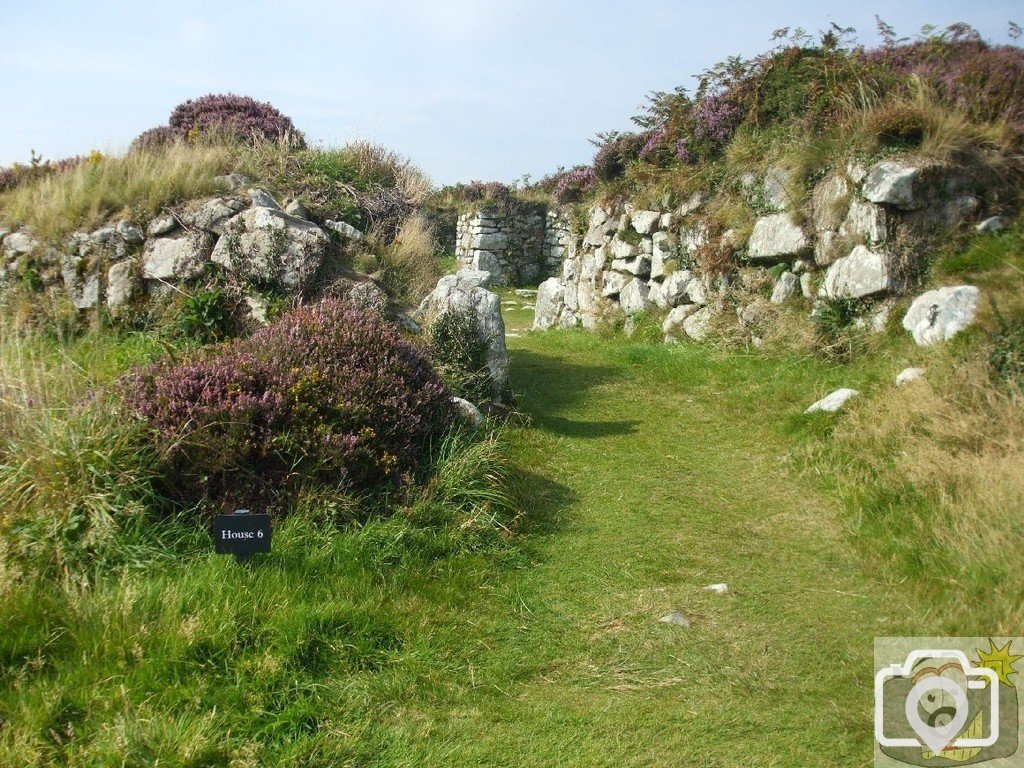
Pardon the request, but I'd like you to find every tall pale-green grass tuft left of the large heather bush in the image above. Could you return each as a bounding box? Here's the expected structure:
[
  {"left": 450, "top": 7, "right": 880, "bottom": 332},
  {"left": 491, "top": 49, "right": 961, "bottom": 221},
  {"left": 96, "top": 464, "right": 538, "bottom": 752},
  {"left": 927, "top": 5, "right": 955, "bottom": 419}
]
[{"left": 0, "top": 334, "right": 163, "bottom": 581}]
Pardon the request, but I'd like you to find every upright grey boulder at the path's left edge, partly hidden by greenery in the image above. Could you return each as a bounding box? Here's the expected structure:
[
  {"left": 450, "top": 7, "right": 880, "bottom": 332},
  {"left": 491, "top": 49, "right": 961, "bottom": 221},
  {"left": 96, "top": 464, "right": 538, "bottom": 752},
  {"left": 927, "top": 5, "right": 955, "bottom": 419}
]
[{"left": 414, "top": 274, "right": 509, "bottom": 401}]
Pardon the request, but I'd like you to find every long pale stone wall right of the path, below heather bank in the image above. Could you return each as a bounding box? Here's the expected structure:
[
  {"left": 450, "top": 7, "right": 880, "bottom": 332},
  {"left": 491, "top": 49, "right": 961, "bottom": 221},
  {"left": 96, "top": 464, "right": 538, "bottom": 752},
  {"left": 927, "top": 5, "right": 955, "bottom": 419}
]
[{"left": 535, "top": 160, "right": 1006, "bottom": 344}]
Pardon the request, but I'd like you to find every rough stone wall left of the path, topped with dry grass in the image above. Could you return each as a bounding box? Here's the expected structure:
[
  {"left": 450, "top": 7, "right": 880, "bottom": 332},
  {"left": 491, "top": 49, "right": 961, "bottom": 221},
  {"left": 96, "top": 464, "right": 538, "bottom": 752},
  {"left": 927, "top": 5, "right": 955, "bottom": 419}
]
[{"left": 0, "top": 174, "right": 380, "bottom": 315}]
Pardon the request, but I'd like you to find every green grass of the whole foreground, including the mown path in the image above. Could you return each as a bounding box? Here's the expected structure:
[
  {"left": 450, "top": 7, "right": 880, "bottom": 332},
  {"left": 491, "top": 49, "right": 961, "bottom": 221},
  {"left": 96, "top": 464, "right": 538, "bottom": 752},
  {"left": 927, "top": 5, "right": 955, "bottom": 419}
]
[{"left": 0, "top": 297, "right": 956, "bottom": 767}]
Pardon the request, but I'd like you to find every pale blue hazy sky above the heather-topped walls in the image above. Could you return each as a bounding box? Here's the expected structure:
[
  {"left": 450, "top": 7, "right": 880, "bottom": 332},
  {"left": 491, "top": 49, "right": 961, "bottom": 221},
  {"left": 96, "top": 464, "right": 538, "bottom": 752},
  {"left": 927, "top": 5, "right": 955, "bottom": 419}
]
[{"left": 0, "top": 0, "right": 1024, "bottom": 184}]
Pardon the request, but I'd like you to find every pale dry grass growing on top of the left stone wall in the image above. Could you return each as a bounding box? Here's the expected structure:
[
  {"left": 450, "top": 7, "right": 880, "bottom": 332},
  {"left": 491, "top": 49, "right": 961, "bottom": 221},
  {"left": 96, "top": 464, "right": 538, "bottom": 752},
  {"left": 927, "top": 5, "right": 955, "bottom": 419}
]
[{"left": 0, "top": 142, "right": 232, "bottom": 241}]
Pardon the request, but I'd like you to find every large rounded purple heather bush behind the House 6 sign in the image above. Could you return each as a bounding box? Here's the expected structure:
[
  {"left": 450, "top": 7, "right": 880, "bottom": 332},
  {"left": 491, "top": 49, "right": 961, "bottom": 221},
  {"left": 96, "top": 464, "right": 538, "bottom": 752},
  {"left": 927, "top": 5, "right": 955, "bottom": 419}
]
[{"left": 124, "top": 299, "right": 456, "bottom": 512}]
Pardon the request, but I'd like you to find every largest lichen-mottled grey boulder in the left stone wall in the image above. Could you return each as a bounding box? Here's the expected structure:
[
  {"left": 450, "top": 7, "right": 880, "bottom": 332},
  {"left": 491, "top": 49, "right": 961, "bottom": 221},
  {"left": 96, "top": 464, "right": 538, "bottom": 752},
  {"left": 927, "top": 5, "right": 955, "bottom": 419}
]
[{"left": 212, "top": 207, "right": 329, "bottom": 291}]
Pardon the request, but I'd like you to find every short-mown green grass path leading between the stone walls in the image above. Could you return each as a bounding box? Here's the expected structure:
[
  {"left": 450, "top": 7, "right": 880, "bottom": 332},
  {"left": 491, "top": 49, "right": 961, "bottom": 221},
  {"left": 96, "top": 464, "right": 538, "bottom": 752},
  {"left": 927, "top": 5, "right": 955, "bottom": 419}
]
[{"left": 403, "top": 303, "right": 919, "bottom": 767}]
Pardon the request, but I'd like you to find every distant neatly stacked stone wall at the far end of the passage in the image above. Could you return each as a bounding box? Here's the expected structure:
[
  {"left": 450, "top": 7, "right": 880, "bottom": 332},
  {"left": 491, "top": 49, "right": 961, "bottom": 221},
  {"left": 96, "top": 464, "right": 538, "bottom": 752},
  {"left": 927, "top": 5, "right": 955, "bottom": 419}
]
[{"left": 455, "top": 205, "right": 574, "bottom": 286}]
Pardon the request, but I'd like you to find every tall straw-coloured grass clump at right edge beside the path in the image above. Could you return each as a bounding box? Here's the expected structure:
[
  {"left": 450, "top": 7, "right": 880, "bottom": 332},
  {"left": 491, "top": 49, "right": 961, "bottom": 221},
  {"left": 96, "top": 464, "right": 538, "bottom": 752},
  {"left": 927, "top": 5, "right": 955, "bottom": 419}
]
[{"left": 835, "top": 351, "right": 1024, "bottom": 633}]
